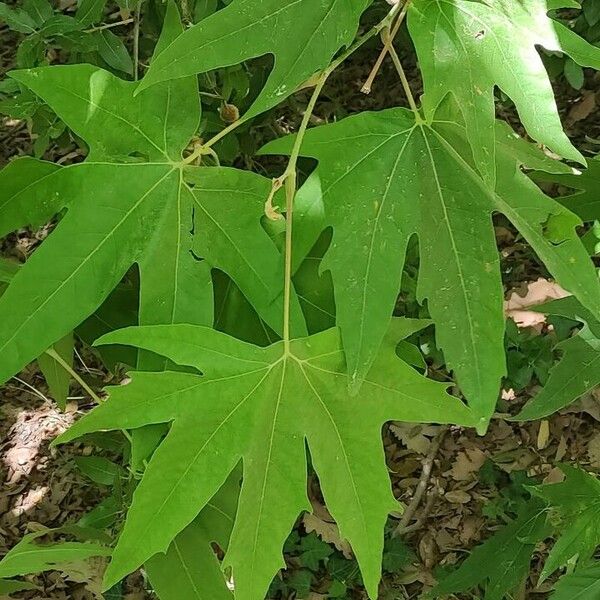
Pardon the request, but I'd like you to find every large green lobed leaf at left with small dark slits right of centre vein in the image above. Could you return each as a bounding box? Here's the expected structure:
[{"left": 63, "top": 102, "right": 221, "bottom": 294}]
[{"left": 0, "top": 4, "right": 306, "bottom": 381}]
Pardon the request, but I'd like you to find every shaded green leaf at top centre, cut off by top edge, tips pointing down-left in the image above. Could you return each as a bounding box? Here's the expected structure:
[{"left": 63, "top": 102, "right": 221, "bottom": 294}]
[{"left": 140, "top": 0, "right": 369, "bottom": 118}]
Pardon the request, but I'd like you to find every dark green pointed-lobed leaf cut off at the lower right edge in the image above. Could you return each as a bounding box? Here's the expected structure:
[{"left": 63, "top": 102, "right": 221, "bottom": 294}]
[{"left": 531, "top": 465, "right": 600, "bottom": 581}]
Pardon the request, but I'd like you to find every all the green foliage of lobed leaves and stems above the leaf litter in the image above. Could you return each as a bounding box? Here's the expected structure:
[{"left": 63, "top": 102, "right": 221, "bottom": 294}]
[{"left": 0, "top": 0, "right": 600, "bottom": 600}]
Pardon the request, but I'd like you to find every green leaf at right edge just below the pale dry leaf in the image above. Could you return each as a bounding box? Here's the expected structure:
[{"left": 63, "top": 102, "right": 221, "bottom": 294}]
[{"left": 515, "top": 297, "right": 600, "bottom": 421}]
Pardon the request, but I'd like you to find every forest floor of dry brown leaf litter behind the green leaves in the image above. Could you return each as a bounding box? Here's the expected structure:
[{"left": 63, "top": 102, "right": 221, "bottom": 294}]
[{"left": 0, "top": 11, "right": 600, "bottom": 600}]
